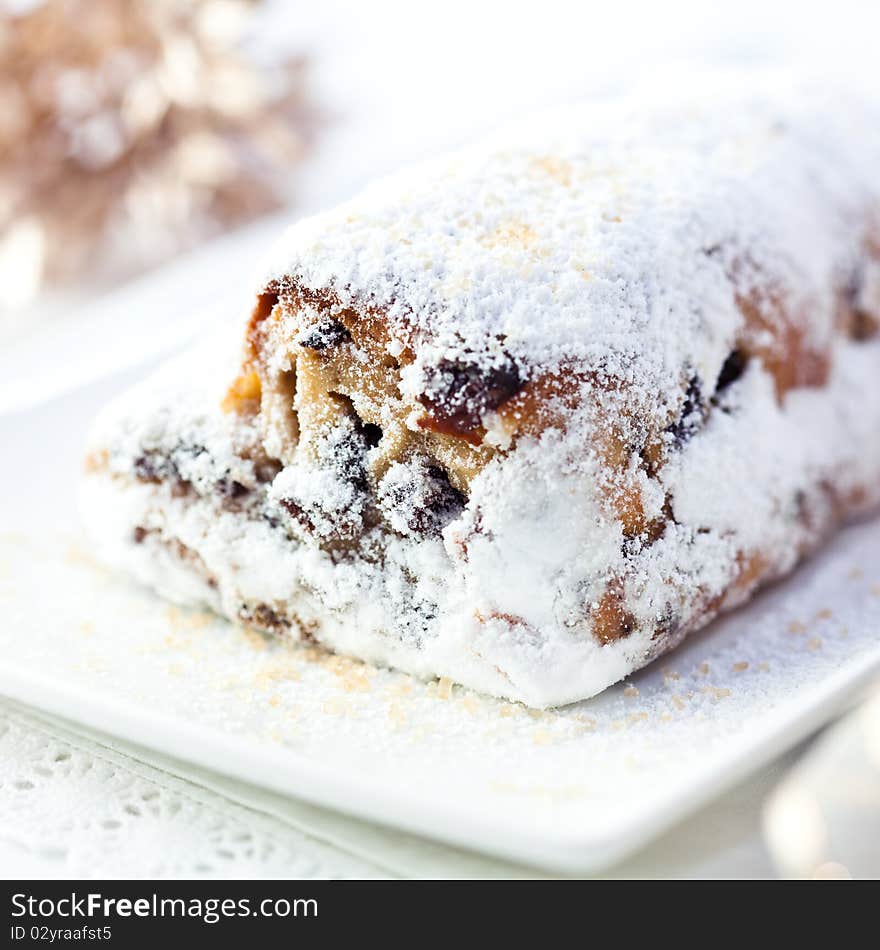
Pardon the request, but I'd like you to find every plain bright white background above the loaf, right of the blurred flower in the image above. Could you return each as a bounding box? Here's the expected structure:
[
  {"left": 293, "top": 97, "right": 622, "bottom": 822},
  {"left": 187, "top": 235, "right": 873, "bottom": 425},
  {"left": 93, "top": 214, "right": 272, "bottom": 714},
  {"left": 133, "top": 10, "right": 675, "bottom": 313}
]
[{"left": 280, "top": 0, "right": 880, "bottom": 204}]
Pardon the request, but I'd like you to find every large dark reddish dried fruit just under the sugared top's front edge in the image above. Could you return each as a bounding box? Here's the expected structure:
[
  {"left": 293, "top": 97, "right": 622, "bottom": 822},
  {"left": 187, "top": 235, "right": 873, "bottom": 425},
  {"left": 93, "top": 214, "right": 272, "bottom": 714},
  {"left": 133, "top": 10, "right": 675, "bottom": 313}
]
[{"left": 419, "top": 359, "right": 523, "bottom": 444}]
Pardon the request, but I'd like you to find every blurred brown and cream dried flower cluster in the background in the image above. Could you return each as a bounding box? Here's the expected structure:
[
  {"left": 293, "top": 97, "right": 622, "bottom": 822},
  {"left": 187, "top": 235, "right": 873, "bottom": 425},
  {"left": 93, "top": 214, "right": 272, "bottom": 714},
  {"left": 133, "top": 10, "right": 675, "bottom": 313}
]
[{"left": 0, "top": 0, "right": 314, "bottom": 306}]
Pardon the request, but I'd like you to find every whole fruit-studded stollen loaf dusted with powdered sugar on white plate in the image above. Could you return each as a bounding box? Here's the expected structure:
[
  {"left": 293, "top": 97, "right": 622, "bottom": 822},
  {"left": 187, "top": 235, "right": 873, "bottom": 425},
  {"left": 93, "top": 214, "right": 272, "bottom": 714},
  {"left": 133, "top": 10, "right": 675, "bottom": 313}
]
[{"left": 83, "top": 82, "right": 880, "bottom": 706}]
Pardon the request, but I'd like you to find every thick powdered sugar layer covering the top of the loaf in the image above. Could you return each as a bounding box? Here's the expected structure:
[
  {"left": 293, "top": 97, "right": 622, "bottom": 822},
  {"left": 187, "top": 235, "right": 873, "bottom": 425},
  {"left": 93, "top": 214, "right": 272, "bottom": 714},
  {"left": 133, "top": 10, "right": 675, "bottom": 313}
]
[{"left": 264, "top": 77, "right": 880, "bottom": 410}]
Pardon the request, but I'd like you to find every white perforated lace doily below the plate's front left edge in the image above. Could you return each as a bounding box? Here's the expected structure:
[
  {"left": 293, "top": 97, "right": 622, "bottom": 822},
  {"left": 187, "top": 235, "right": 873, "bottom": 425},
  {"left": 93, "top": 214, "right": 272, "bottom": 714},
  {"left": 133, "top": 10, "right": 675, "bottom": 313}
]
[{"left": 0, "top": 702, "right": 387, "bottom": 878}]
